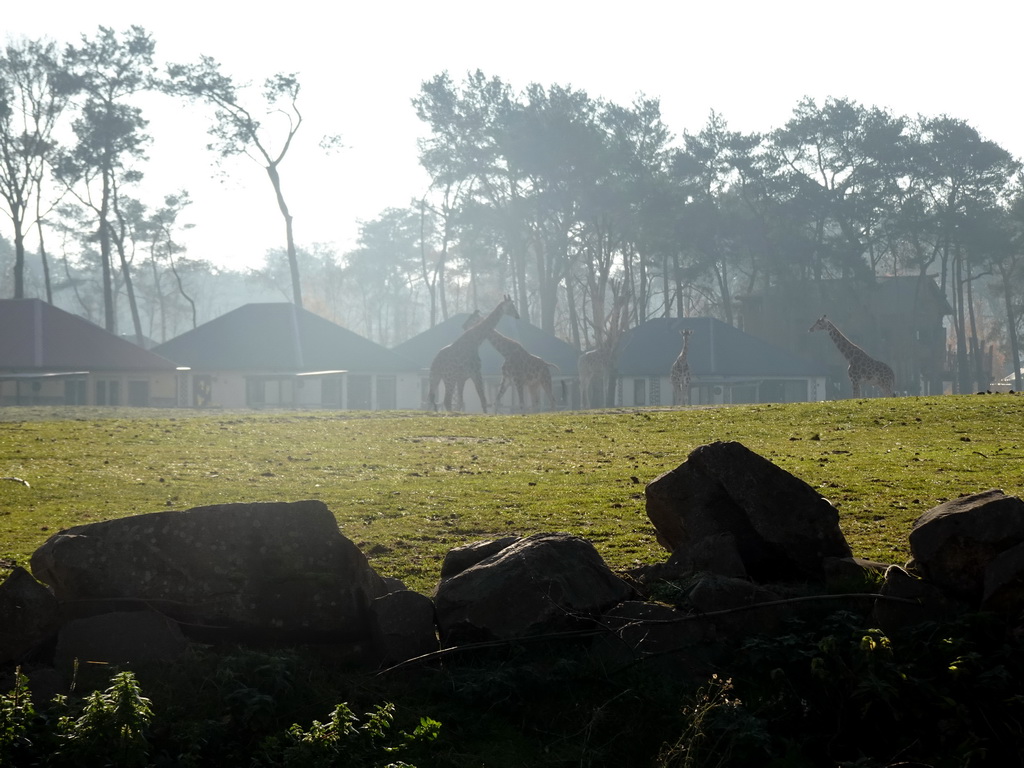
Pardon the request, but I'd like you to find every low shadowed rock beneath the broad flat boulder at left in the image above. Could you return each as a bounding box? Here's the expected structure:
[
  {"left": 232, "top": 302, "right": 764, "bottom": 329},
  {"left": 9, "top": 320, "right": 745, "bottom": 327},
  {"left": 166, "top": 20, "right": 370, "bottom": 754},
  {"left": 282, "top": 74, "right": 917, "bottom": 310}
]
[{"left": 53, "top": 610, "right": 188, "bottom": 680}]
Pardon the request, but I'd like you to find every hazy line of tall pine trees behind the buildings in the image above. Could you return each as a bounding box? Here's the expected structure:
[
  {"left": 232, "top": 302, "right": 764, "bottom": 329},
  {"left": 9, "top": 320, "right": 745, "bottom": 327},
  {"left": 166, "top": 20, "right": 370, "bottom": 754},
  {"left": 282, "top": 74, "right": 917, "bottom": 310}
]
[{"left": 0, "top": 27, "right": 1024, "bottom": 386}]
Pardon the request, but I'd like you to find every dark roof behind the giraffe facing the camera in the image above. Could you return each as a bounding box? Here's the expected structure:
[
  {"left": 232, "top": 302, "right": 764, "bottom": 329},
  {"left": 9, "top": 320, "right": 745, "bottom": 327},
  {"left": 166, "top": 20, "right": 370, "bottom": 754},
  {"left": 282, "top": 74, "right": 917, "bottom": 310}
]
[{"left": 616, "top": 317, "right": 826, "bottom": 377}]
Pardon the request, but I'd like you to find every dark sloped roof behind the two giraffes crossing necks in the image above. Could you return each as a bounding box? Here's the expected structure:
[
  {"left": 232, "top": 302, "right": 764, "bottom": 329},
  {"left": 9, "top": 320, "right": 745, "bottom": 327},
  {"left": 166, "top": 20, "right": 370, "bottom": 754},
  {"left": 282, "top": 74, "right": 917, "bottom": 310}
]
[{"left": 393, "top": 312, "right": 580, "bottom": 377}]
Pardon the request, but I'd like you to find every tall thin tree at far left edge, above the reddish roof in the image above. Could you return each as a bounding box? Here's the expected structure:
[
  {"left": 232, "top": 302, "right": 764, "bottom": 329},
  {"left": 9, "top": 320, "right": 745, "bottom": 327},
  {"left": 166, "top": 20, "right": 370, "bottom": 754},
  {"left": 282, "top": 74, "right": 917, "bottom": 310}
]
[{"left": 0, "top": 40, "right": 68, "bottom": 300}]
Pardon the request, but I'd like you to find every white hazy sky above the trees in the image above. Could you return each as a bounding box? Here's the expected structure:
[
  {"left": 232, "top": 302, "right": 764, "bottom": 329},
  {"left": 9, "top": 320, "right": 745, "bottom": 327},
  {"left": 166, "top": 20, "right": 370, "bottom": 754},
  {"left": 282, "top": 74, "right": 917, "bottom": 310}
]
[{"left": 0, "top": 0, "right": 1024, "bottom": 268}]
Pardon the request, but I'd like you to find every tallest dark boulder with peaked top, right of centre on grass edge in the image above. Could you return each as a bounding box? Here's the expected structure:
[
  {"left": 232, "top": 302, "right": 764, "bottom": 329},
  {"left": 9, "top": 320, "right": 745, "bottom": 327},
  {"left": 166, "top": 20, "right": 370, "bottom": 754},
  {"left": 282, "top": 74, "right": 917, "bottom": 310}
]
[{"left": 645, "top": 442, "right": 852, "bottom": 582}]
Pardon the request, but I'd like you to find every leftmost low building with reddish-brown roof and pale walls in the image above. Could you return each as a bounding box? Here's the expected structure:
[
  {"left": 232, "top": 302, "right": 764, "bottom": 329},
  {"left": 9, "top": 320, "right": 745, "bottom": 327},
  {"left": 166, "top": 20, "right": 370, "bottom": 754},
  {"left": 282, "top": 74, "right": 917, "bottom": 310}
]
[{"left": 0, "top": 299, "right": 187, "bottom": 407}]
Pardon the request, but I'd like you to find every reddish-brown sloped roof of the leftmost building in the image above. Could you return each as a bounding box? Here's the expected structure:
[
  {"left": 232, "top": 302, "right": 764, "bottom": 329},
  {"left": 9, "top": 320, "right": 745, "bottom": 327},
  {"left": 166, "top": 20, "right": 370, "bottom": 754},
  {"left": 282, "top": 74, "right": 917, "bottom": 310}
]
[{"left": 0, "top": 299, "right": 175, "bottom": 373}]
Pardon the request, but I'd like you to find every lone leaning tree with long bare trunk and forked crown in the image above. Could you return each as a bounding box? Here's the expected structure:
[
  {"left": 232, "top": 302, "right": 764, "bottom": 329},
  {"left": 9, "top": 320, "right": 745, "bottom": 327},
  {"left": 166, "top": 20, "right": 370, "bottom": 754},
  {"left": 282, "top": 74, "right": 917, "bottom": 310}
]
[{"left": 168, "top": 56, "right": 302, "bottom": 307}]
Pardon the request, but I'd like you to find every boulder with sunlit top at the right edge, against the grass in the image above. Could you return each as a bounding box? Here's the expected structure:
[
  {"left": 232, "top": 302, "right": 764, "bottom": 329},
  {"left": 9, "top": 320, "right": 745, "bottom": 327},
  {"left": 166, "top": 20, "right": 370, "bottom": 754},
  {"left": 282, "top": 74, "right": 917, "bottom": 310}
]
[{"left": 909, "top": 489, "right": 1024, "bottom": 607}]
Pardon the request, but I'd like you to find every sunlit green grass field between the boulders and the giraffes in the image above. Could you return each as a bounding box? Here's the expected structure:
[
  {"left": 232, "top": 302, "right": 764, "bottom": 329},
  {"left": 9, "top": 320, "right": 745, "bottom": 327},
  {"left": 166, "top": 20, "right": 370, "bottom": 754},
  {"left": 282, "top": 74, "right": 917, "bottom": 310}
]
[{"left": 0, "top": 395, "right": 1024, "bottom": 592}]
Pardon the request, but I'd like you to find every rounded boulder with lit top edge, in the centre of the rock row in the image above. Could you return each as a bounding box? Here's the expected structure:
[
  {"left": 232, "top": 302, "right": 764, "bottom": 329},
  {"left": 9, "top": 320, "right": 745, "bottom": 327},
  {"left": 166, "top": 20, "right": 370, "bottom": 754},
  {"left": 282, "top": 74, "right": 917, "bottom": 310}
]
[{"left": 434, "top": 534, "right": 633, "bottom": 646}]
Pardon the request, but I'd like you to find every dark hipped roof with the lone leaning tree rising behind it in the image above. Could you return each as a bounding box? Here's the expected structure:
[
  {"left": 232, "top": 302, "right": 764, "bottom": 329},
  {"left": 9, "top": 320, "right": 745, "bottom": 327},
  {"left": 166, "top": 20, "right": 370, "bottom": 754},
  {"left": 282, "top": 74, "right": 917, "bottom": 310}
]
[{"left": 154, "top": 302, "right": 417, "bottom": 373}]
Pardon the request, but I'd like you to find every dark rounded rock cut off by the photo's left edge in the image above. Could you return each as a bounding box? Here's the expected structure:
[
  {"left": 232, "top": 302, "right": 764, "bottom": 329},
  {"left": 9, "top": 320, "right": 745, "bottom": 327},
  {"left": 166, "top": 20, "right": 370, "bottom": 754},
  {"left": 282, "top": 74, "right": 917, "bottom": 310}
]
[{"left": 0, "top": 567, "right": 60, "bottom": 665}]
